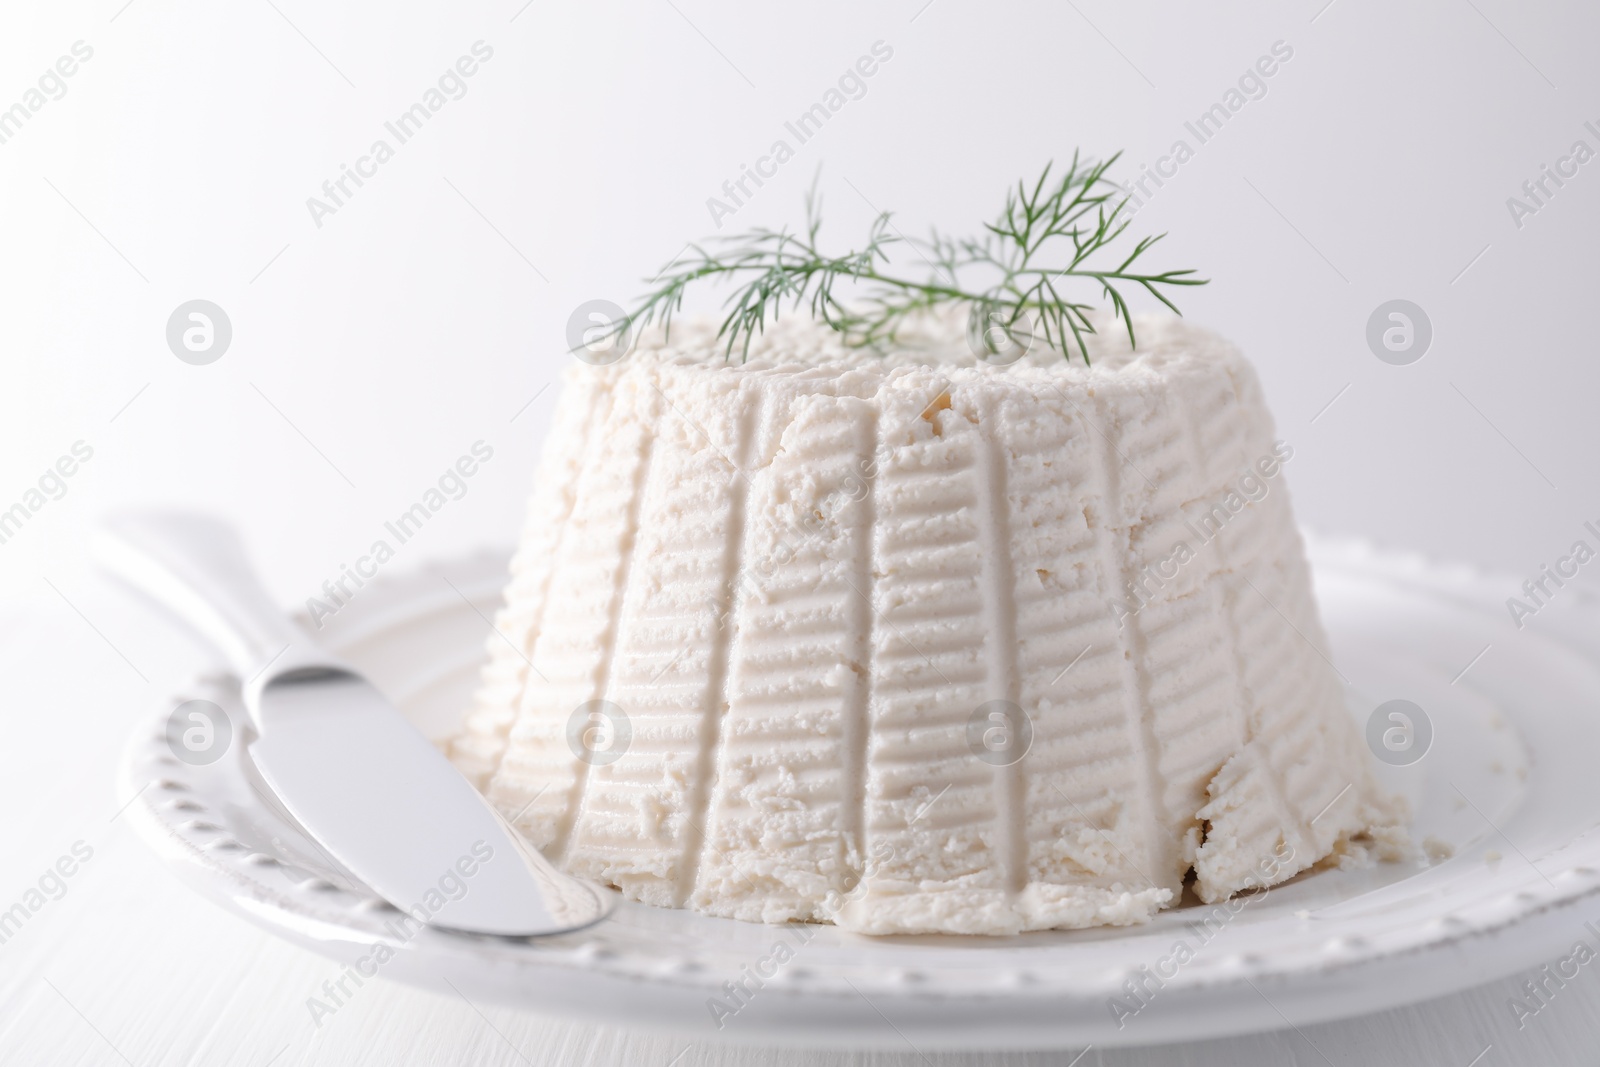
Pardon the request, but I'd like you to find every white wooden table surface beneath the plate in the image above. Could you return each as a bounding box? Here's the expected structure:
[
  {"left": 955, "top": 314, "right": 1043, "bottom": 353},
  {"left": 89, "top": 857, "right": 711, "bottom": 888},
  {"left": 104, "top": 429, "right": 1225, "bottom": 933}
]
[{"left": 0, "top": 591, "right": 1600, "bottom": 1067}]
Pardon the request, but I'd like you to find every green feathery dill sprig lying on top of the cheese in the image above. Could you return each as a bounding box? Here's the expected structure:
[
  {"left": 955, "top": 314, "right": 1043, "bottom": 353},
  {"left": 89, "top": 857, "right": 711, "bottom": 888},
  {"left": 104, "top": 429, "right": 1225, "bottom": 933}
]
[{"left": 603, "top": 152, "right": 1206, "bottom": 365}]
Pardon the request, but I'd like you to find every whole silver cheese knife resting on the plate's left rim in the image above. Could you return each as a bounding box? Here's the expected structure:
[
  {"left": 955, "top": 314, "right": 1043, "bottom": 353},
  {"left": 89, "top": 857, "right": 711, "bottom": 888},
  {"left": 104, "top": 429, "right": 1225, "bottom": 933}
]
[{"left": 96, "top": 514, "right": 614, "bottom": 936}]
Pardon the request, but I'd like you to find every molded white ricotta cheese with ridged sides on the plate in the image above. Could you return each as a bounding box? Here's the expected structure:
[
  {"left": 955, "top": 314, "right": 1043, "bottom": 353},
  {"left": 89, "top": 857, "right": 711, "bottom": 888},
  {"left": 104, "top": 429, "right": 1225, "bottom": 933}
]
[{"left": 453, "top": 310, "right": 1395, "bottom": 934}]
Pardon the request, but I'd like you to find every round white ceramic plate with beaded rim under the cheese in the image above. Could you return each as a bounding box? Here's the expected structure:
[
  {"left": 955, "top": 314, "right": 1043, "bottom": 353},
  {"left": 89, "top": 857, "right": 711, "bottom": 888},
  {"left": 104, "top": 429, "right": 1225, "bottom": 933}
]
[{"left": 123, "top": 541, "right": 1600, "bottom": 1051}]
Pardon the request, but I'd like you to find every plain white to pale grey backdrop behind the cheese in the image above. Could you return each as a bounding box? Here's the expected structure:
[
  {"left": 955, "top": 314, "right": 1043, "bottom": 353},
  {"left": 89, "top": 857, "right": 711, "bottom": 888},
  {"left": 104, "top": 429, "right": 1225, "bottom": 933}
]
[{"left": 0, "top": 0, "right": 1600, "bottom": 1062}]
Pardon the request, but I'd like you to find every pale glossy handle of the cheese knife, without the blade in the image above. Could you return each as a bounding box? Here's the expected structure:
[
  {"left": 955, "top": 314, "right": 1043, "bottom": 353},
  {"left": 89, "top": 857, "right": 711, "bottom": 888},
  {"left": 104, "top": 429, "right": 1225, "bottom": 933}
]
[{"left": 94, "top": 512, "right": 349, "bottom": 716}]
